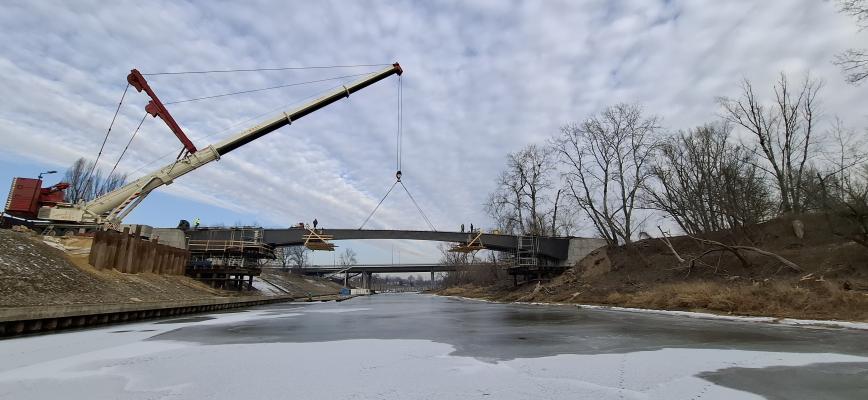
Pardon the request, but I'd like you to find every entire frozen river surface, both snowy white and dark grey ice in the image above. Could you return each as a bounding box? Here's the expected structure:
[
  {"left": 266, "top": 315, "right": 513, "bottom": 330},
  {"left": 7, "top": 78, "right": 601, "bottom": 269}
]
[{"left": 0, "top": 295, "right": 868, "bottom": 400}]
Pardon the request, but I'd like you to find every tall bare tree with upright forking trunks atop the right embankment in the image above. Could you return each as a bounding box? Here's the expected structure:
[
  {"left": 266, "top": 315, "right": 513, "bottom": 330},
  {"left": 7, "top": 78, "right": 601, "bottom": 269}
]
[{"left": 718, "top": 73, "right": 823, "bottom": 214}]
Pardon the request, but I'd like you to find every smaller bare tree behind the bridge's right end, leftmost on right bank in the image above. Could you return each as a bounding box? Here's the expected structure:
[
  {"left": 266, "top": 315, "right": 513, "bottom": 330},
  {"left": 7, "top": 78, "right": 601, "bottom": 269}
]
[{"left": 485, "top": 144, "right": 563, "bottom": 235}]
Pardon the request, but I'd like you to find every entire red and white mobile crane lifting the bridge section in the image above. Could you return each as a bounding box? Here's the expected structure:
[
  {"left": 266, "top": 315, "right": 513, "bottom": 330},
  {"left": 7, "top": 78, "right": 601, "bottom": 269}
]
[{"left": 5, "top": 63, "right": 403, "bottom": 228}]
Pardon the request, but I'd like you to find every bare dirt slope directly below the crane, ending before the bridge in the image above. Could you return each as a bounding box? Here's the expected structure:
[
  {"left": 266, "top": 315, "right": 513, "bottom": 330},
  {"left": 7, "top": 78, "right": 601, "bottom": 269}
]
[{"left": 0, "top": 229, "right": 258, "bottom": 307}]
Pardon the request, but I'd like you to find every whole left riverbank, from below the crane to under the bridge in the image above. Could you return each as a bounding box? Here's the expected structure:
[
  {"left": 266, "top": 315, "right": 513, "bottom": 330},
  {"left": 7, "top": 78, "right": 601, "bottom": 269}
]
[{"left": 0, "top": 229, "right": 340, "bottom": 308}]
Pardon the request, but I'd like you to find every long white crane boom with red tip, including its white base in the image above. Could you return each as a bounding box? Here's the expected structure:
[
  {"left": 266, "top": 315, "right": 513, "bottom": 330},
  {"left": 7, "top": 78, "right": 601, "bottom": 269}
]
[{"left": 33, "top": 63, "right": 403, "bottom": 225}]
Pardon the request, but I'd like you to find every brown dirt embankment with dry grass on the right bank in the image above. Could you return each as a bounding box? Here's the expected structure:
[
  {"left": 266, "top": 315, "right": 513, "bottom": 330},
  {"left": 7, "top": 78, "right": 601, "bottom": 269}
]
[{"left": 440, "top": 216, "right": 868, "bottom": 321}]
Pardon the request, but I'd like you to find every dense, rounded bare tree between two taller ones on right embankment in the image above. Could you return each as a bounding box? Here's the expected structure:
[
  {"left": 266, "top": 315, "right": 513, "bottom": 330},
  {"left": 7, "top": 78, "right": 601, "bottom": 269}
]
[{"left": 645, "top": 123, "right": 775, "bottom": 235}]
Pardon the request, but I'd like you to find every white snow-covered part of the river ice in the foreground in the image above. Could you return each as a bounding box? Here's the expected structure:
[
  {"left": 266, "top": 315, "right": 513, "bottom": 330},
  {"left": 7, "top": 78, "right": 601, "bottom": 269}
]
[{"left": 0, "top": 298, "right": 868, "bottom": 400}]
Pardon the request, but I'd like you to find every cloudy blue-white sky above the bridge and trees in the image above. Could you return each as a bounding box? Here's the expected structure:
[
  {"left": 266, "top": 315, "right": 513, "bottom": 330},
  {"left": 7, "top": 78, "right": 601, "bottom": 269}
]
[{"left": 0, "top": 0, "right": 868, "bottom": 262}]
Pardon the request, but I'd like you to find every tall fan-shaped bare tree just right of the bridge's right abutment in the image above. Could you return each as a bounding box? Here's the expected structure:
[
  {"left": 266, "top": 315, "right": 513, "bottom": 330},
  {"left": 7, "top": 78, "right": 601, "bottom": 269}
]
[{"left": 553, "top": 103, "right": 659, "bottom": 245}]
